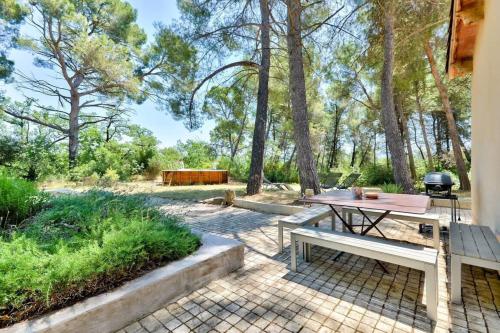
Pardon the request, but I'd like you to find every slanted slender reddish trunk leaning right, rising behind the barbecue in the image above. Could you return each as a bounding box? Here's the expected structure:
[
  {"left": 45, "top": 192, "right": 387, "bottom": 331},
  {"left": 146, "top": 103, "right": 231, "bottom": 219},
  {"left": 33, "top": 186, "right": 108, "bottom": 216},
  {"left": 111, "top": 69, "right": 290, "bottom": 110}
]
[{"left": 424, "top": 41, "right": 470, "bottom": 191}]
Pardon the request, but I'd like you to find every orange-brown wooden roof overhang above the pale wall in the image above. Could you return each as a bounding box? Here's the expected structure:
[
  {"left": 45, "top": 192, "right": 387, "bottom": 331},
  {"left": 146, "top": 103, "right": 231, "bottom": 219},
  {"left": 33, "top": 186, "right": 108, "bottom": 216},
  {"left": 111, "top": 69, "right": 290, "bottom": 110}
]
[{"left": 446, "top": 0, "right": 484, "bottom": 79}]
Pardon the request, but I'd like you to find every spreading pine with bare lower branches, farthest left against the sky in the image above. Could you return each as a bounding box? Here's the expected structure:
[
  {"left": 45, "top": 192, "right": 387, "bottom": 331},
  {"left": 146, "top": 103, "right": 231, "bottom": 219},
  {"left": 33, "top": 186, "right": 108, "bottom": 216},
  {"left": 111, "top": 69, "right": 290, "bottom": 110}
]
[{"left": 5, "top": 0, "right": 194, "bottom": 168}]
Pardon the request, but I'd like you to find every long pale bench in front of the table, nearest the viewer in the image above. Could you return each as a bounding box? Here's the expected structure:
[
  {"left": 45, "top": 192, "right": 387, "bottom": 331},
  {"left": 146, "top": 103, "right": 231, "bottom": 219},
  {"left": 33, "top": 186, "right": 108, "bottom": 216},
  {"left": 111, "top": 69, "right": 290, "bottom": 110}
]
[{"left": 290, "top": 227, "right": 439, "bottom": 320}]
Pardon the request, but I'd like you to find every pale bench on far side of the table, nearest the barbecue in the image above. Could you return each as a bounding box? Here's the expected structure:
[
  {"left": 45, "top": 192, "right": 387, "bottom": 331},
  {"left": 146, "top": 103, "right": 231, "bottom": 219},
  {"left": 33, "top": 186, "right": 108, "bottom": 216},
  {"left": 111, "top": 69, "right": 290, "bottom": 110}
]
[{"left": 342, "top": 207, "right": 439, "bottom": 251}]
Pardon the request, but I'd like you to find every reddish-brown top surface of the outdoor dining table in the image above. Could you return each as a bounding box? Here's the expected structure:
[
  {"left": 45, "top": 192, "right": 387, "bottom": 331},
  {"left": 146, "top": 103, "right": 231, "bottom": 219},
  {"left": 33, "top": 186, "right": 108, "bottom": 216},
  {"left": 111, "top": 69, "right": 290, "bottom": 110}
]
[{"left": 302, "top": 191, "right": 429, "bottom": 214}]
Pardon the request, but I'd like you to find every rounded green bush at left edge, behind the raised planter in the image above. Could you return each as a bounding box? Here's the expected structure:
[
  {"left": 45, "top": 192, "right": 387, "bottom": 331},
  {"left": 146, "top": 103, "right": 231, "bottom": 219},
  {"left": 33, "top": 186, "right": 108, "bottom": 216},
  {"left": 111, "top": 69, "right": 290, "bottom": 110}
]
[{"left": 0, "top": 173, "right": 48, "bottom": 229}]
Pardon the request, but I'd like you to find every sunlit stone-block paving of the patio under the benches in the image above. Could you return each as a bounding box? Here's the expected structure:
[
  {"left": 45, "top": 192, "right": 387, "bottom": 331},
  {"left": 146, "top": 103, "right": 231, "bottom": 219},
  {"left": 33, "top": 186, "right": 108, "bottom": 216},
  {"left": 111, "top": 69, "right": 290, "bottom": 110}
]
[{"left": 119, "top": 201, "right": 500, "bottom": 333}]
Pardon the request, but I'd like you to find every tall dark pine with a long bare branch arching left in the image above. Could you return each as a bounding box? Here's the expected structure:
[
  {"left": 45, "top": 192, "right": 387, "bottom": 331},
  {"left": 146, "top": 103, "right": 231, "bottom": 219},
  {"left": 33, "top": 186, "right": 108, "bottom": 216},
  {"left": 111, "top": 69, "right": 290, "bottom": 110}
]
[{"left": 179, "top": 0, "right": 271, "bottom": 195}]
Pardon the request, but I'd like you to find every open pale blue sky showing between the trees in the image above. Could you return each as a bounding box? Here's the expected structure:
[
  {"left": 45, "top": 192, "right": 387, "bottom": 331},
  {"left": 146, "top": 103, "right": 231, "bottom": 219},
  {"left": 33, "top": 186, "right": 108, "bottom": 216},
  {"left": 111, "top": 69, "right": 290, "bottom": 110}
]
[{"left": 0, "top": 0, "right": 213, "bottom": 147}]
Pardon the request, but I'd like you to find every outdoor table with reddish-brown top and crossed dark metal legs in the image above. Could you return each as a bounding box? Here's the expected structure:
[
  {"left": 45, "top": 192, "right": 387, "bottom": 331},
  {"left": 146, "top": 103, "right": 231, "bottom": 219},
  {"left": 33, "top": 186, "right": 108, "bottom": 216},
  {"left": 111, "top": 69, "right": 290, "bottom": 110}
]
[{"left": 302, "top": 191, "right": 429, "bottom": 271}]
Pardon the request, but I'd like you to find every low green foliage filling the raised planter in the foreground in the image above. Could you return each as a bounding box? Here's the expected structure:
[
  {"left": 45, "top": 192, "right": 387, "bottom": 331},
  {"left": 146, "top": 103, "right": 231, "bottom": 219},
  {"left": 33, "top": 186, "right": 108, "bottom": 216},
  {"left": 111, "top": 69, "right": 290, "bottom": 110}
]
[{"left": 0, "top": 192, "right": 200, "bottom": 327}]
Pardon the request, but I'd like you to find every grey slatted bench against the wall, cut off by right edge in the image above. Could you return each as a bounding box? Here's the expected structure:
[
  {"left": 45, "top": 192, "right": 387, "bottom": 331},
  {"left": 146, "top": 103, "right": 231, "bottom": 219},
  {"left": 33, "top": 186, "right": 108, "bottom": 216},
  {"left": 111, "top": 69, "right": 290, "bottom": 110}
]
[{"left": 450, "top": 223, "right": 500, "bottom": 303}]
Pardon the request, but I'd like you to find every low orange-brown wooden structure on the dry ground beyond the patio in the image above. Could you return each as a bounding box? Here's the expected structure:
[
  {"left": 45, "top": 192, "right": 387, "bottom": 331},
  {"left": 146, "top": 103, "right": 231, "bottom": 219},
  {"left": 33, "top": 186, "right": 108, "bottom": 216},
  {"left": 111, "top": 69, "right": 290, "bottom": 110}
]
[{"left": 162, "top": 169, "right": 228, "bottom": 186}]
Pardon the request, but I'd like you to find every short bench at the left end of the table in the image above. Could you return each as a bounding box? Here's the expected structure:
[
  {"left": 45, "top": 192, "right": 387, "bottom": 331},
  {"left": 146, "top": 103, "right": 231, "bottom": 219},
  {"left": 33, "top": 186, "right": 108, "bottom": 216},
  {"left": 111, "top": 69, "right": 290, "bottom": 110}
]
[{"left": 278, "top": 205, "right": 335, "bottom": 253}]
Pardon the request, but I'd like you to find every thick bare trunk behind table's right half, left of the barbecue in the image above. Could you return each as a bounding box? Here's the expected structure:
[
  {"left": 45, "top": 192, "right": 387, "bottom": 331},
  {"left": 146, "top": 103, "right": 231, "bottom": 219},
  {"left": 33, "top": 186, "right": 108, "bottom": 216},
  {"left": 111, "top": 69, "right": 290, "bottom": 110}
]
[{"left": 381, "top": 1, "right": 415, "bottom": 193}]
